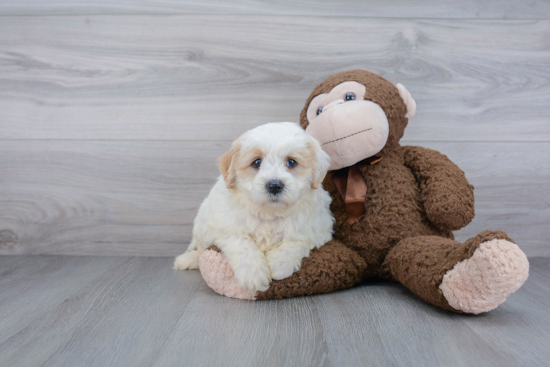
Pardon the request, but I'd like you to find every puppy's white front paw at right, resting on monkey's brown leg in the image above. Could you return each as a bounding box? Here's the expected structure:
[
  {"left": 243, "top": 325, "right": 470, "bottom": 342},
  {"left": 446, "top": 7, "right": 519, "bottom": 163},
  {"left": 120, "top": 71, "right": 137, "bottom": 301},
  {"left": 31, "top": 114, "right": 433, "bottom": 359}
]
[{"left": 265, "top": 241, "right": 309, "bottom": 280}]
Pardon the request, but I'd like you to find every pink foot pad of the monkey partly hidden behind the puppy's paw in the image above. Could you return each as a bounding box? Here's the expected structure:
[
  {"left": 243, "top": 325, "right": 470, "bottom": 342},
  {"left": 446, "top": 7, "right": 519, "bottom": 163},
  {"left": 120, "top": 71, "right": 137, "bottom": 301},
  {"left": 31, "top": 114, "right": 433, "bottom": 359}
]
[{"left": 199, "top": 250, "right": 255, "bottom": 300}]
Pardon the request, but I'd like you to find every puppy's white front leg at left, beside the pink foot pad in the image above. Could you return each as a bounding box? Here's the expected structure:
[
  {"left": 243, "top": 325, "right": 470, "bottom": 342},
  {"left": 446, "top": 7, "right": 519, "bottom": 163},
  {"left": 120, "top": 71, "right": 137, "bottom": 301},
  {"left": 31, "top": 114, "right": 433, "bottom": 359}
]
[{"left": 218, "top": 237, "right": 271, "bottom": 292}]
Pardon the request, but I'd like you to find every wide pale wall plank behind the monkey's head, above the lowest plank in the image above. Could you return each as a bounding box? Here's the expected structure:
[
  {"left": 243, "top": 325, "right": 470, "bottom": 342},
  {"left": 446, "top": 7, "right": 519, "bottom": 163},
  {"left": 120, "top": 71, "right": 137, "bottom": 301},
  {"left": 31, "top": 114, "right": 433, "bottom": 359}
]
[{"left": 0, "top": 15, "right": 550, "bottom": 141}]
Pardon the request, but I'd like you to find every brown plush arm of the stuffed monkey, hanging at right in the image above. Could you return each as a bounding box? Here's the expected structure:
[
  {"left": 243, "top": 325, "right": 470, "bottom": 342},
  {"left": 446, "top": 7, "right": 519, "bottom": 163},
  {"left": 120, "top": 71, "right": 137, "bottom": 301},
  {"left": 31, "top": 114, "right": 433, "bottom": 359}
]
[{"left": 403, "top": 146, "right": 474, "bottom": 230}]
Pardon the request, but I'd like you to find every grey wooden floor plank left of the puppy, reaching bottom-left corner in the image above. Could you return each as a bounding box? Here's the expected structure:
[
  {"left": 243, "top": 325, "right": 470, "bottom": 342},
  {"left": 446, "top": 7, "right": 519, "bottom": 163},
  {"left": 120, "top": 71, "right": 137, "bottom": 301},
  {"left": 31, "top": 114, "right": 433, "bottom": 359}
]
[{"left": 0, "top": 257, "right": 206, "bottom": 366}]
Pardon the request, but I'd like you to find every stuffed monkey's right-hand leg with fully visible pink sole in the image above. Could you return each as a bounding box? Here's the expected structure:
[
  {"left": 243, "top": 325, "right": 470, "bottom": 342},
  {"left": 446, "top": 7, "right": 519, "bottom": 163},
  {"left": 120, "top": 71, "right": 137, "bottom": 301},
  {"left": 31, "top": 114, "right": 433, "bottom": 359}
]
[{"left": 383, "top": 231, "right": 529, "bottom": 314}]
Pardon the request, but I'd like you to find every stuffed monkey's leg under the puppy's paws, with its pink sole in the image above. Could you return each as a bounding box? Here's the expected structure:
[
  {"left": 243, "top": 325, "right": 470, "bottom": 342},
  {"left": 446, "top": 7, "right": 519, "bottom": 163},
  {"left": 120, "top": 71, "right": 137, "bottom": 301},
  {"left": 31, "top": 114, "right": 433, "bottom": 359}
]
[{"left": 199, "top": 241, "right": 367, "bottom": 300}]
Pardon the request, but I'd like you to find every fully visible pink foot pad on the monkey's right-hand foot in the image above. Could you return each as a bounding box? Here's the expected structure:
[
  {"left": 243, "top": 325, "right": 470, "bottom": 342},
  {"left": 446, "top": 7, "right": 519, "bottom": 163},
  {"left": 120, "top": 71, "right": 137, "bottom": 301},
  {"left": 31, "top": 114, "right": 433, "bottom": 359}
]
[{"left": 439, "top": 239, "right": 529, "bottom": 314}]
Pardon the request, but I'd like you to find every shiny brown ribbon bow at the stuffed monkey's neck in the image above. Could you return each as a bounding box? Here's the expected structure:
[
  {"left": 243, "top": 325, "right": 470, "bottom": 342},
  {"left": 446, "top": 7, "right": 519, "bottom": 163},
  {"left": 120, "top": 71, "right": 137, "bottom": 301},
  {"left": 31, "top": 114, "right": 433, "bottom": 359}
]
[{"left": 332, "top": 156, "right": 382, "bottom": 225}]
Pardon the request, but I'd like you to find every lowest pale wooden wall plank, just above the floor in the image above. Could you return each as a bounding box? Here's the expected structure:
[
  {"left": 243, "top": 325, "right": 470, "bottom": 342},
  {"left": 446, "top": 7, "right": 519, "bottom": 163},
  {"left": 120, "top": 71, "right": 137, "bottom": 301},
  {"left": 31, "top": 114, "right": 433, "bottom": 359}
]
[{"left": 0, "top": 141, "right": 550, "bottom": 256}]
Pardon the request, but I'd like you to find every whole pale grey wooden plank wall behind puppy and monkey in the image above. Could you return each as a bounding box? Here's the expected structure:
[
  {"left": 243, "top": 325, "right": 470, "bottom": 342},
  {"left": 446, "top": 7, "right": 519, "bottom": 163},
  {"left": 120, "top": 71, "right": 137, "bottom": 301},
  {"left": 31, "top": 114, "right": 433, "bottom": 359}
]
[{"left": 0, "top": 0, "right": 550, "bottom": 256}]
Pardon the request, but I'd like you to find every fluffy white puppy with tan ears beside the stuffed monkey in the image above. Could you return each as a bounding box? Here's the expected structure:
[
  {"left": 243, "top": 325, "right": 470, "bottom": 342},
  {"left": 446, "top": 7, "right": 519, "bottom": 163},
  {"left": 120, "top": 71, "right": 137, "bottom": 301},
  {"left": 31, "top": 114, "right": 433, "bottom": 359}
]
[{"left": 174, "top": 122, "right": 334, "bottom": 292}]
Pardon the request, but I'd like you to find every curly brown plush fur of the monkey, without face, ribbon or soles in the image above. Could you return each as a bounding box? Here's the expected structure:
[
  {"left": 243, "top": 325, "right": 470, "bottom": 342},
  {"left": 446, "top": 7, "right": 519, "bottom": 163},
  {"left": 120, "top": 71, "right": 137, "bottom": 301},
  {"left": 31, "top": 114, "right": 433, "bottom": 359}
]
[{"left": 252, "top": 70, "right": 507, "bottom": 312}]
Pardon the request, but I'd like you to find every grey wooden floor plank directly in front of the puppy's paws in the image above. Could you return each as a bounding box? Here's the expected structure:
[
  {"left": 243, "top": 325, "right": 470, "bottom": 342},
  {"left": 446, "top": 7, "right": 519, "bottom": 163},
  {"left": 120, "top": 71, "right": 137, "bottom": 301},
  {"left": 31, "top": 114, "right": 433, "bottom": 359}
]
[{"left": 153, "top": 286, "right": 334, "bottom": 367}]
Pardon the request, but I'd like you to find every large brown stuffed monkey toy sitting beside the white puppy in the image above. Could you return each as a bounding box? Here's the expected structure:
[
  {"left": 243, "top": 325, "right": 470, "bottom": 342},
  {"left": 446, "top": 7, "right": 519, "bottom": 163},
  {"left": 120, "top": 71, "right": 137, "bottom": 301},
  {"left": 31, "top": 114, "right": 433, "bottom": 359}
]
[{"left": 199, "top": 70, "right": 529, "bottom": 314}]
